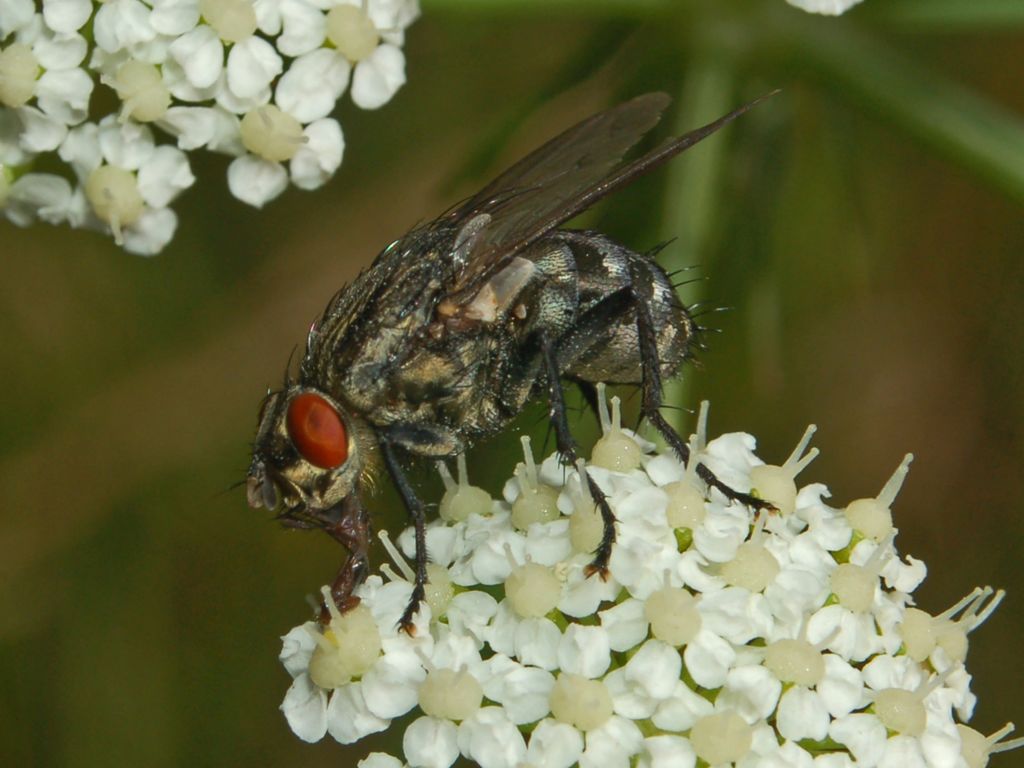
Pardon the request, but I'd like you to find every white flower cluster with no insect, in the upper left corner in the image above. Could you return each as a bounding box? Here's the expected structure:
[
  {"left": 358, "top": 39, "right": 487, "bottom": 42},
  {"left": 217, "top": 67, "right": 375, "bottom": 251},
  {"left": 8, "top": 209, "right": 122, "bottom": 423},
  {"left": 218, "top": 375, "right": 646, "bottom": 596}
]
[{"left": 0, "top": 0, "right": 419, "bottom": 254}]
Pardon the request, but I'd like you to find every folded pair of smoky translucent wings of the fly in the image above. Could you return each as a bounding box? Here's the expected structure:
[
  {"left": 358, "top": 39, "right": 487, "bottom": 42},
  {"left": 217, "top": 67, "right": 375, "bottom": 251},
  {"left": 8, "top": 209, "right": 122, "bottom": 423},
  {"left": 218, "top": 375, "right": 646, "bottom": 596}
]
[{"left": 441, "top": 93, "right": 763, "bottom": 307}]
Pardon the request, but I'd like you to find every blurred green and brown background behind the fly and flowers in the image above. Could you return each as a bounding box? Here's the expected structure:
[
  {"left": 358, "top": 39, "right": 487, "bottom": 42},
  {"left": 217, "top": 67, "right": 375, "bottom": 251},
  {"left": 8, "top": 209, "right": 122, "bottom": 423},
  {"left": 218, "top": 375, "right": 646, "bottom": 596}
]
[{"left": 0, "top": 0, "right": 1024, "bottom": 767}]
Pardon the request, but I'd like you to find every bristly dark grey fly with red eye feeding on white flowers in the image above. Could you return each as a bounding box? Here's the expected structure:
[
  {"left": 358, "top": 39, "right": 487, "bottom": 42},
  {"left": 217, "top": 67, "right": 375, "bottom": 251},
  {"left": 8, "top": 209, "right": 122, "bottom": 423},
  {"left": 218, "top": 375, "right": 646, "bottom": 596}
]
[{"left": 247, "top": 93, "right": 770, "bottom": 632}]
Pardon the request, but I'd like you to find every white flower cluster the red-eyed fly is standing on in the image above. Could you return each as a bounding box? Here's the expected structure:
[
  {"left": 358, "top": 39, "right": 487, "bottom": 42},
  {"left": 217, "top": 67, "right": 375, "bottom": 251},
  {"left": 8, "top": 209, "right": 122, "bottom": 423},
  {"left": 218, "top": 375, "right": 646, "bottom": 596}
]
[{"left": 281, "top": 400, "right": 1017, "bottom": 768}]
